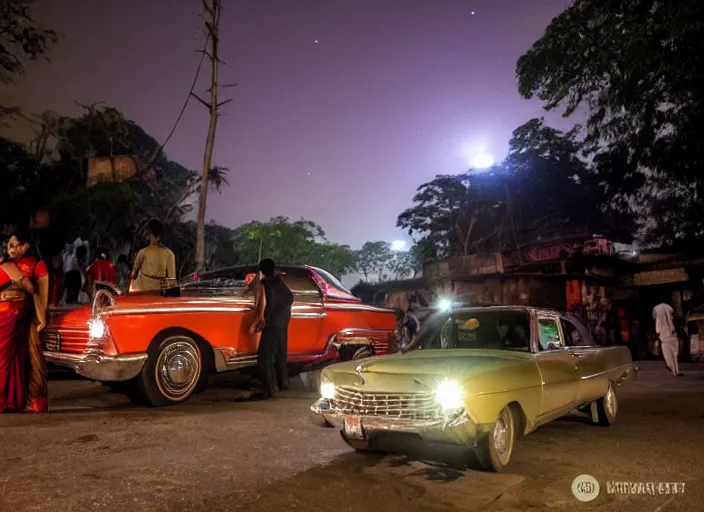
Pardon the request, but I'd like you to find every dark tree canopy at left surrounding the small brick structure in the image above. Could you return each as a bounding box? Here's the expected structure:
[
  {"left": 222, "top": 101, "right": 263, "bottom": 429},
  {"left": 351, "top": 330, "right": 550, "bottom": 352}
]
[{"left": 0, "top": 105, "right": 229, "bottom": 268}]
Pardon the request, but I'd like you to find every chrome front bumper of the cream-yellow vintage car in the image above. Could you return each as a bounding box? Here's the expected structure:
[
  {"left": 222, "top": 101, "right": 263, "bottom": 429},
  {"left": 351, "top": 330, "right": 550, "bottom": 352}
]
[{"left": 310, "top": 398, "right": 480, "bottom": 447}]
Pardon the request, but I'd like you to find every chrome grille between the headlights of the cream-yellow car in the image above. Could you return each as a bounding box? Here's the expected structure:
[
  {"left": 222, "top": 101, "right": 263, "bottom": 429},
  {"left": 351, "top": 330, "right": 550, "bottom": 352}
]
[{"left": 330, "top": 387, "right": 440, "bottom": 420}]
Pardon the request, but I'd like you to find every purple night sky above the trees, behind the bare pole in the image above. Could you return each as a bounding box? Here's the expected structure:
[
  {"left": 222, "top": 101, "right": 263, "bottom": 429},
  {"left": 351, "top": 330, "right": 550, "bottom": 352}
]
[{"left": 10, "top": 0, "right": 570, "bottom": 247}]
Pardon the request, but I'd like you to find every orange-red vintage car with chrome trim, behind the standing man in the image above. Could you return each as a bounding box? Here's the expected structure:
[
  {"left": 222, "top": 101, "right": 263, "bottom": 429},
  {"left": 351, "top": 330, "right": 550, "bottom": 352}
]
[{"left": 44, "top": 266, "right": 397, "bottom": 406}]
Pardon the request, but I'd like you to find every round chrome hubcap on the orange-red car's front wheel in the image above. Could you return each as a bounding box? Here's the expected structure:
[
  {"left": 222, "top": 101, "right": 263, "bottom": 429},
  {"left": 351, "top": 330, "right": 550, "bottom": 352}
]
[{"left": 156, "top": 336, "right": 201, "bottom": 401}]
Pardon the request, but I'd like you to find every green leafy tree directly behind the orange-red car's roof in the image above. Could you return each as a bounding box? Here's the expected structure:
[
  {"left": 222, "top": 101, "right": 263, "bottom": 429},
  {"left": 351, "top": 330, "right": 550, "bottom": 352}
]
[{"left": 232, "top": 217, "right": 355, "bottom": 276}]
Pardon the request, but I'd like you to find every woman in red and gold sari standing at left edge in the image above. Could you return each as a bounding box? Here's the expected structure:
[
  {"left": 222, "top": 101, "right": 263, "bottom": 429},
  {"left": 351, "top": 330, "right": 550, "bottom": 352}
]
[{"left": 0, "top": 232, "right": 49, "bottom": 412}]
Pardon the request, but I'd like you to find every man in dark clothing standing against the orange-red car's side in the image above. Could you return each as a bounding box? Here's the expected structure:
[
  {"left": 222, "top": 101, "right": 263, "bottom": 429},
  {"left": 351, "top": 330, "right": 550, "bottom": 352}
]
[{"left": 250, "top": 259, "right": 293, "bottom": 398}]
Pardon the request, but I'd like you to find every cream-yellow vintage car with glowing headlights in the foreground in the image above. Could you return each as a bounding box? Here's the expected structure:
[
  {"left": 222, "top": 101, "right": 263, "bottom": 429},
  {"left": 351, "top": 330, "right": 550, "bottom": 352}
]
[{"left": 311, "top": 306, "right": 637, "bottom": 471}]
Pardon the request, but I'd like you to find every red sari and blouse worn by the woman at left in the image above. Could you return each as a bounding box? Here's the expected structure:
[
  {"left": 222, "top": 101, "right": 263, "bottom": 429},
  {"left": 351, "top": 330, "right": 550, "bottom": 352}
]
[{"left": 0, "top": 257, "right": 48, "bottom": 412}]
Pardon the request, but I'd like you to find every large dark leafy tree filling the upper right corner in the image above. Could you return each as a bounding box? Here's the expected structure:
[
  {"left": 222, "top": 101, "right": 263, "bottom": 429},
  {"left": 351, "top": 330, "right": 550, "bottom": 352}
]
[{"left": 516, "top": 0, "right": 704, "bottom": 246}]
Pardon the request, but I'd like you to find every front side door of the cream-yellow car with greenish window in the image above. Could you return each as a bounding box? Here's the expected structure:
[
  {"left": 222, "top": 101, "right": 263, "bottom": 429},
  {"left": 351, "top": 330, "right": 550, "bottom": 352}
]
[{"left": 534, "top": 315, "right": 579, "bottom": 417}]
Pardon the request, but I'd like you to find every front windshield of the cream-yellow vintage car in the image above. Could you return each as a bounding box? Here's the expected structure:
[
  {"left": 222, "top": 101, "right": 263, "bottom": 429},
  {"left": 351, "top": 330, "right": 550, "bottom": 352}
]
[{"left": 418, "top": 309, "right": 530, "bottom": 352}]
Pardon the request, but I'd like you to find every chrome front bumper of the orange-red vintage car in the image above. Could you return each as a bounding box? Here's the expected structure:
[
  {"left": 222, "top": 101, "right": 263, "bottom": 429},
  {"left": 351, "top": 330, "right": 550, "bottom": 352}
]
[{"left": 44, "top": 351, "right": 147, "bottom": 382}]
